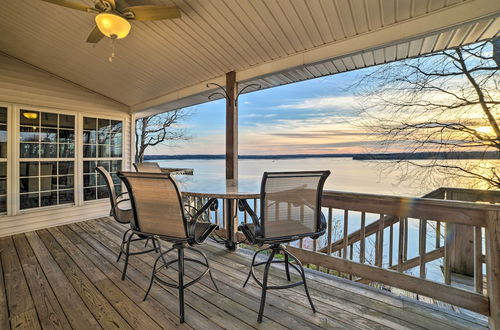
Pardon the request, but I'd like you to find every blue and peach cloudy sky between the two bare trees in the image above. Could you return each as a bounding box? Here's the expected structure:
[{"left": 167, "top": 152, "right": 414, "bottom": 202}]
[{"left": 148, "top": 70, "right": 382, "bottom": 155}]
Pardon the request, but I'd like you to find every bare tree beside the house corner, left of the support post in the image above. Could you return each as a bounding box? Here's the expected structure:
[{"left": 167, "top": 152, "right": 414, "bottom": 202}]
[{"left": 135, "top": 109, "right": 190, "bottom": 163}]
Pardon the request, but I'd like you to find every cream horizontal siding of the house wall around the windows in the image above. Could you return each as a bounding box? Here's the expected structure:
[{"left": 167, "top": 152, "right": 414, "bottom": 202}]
[{"left": 0, "top": 55, "right": 132, "bottom": 237}]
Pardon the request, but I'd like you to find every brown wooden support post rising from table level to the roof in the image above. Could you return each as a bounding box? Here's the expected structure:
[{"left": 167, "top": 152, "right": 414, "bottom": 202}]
[{"left": 226, "top": 71, "right": 238, "bottom": 181}]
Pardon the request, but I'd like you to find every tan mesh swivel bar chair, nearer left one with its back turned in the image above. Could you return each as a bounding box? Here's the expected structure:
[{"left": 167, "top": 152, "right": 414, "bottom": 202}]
[{"left": 118, "top": 172, "right": 218, "bottom": 323}]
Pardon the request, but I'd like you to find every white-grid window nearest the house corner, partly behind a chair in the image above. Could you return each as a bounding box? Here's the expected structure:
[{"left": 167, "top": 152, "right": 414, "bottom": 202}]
[{"left": 83, "top": 117, "right": 123, "bottom": 201}]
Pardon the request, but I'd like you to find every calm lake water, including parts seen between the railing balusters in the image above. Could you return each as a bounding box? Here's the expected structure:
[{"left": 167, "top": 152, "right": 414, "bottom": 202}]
[{"left": 159, "top": 158, "right": 492, "bottom": 282}]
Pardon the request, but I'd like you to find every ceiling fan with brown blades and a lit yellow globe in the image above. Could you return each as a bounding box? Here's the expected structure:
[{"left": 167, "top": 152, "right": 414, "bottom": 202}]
[{"left": 42, "top": 0, "right": 181, "bottom": 43}]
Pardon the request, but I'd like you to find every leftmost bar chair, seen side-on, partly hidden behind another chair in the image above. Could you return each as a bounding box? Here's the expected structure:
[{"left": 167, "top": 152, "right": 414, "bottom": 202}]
[{"left": 95, "top": 166, "right": 158, "bottom": 280}]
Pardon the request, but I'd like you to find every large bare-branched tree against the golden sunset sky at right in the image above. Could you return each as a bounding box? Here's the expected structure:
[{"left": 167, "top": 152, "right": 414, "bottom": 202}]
[{"left": 354, "top": 40, "right": 500, "bottom": 188}]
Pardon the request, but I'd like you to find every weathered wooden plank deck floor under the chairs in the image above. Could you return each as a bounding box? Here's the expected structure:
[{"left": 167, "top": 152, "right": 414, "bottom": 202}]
[{"left": 0, "top": 218, "right": 486, "bottom": 330}]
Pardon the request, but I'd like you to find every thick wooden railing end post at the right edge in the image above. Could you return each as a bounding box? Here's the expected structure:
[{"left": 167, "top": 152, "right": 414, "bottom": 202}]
[{"left": 486, "top": 211, "right": 500, "bottom": 330}]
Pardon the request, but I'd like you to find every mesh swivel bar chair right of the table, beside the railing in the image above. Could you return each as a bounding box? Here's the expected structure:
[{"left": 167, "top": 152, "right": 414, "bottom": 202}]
[{"left": 239, "top": 171, "right": 330, "bottom": 322}]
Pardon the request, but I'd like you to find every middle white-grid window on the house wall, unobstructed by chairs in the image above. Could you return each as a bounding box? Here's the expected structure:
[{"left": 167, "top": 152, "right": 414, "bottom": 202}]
[{"left": 19, "top": 110, "right": 75, "bottom": 209}]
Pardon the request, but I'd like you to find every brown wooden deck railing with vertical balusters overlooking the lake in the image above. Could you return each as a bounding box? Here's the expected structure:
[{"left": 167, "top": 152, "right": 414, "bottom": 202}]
[{"left": 187, "top": 188, "right": 500, "bottom": 329}]
